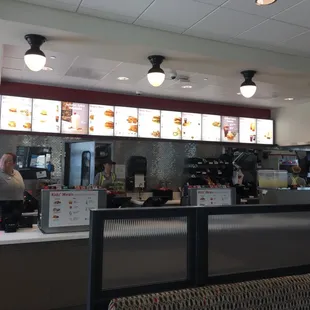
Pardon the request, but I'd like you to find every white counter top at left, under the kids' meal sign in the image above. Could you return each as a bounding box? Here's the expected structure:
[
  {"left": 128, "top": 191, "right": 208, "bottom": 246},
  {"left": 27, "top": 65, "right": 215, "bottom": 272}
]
[{"left": 0, "top": 225, "right": 89, "bottom": 246}]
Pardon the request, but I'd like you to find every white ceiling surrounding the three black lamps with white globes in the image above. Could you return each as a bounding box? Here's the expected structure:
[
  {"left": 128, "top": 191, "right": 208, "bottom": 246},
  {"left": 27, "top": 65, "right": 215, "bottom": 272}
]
[{"left": 0, "top": 0, "right": 310, "bottom": 108}]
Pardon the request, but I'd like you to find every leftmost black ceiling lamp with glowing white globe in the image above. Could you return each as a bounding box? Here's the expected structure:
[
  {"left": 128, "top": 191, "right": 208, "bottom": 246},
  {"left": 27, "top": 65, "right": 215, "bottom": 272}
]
[{"left": 24, "top": 34, "right": 46, "bottom": 72}]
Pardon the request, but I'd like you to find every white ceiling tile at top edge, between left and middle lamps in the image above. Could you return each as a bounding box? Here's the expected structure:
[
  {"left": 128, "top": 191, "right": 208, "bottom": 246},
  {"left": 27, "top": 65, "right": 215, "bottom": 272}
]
[{"left": 78, "top": 0, "right": 154, "bottom": 21}]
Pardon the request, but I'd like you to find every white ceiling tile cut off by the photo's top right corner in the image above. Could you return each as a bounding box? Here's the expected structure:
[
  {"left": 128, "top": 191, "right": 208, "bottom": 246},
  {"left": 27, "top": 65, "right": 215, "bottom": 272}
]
[{"left": 274, "top": 0, "right": 310, "bottom": 28}]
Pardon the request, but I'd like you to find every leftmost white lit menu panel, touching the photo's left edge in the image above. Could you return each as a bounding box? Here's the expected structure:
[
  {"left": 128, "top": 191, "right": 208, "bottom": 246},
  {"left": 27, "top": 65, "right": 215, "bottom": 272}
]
[{"left": 1, "top": 96, "right": 32, "bottom": 131}]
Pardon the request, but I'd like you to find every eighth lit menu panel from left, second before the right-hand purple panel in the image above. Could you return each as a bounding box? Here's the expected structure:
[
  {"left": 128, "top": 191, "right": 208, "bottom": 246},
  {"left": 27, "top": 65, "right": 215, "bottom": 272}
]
[{"left": 182, "top": 112, "right": 201, "bottom": 141}]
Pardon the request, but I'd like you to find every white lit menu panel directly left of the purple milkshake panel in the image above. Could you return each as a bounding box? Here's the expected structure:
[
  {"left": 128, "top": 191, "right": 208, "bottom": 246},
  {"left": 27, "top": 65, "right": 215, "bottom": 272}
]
[{"left": 32, "top": 99, "right": 61, "bottom": 133}]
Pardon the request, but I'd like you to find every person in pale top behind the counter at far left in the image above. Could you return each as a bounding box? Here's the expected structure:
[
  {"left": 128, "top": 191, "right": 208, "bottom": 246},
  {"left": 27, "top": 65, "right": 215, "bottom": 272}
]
[{"left": 0, "top": 153, "right": 25, "bottom": 201}]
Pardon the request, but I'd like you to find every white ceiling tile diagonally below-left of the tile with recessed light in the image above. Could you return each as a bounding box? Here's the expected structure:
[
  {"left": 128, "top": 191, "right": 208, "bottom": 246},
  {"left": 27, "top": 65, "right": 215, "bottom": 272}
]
[{"left": 185, "top": 7, "right": 266, "bottom": 37}]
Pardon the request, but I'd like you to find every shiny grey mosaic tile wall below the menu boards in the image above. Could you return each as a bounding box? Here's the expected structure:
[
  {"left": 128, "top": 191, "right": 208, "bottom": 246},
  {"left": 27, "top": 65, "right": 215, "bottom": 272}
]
[{"left": 0, "top": 134, "right": 222, "bottom": 189}]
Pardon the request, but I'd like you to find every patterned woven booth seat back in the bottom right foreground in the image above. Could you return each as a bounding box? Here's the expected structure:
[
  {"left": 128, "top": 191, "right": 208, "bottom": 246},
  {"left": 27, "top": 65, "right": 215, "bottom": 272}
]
[{"left": 107, "top": 274, "right": 310, "bottom": 310}]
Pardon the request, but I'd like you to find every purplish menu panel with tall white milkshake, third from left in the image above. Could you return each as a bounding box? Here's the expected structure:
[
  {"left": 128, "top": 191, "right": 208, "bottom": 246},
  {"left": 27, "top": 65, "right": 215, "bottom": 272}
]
[{"left": 61, "top": 101, "right": 88, "bottom": 135}]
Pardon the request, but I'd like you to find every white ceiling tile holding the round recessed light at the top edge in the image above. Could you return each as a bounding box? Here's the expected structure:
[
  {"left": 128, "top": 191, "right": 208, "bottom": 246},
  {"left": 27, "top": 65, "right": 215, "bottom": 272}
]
[{"left": 223, "top": 0, "right": 302, "bottom": 17}]
